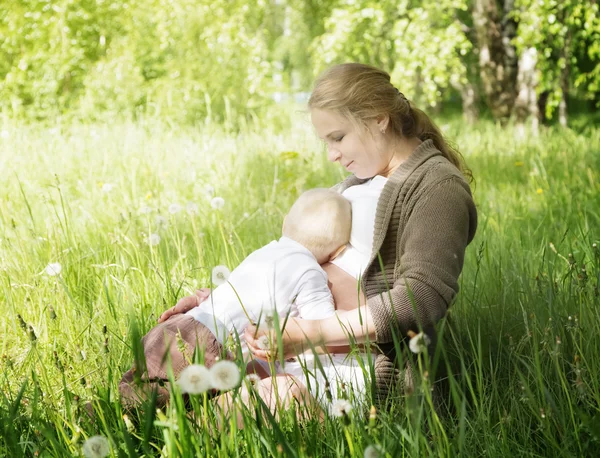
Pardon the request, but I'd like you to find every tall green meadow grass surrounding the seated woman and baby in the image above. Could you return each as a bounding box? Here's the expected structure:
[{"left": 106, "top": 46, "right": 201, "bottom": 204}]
[{"left": 0, "top": 113, "right": 600, "bottom": 457}]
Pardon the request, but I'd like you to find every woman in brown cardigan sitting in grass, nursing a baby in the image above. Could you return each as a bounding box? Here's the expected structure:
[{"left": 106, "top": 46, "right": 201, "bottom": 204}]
[{"left": 159, "top": 64, "right": 477, "bottom": 416}]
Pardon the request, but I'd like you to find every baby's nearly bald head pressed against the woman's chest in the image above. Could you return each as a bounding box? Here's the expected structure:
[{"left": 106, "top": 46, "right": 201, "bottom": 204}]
[{"left": 283, "top": 188, "right": 352, "bottom": 264}]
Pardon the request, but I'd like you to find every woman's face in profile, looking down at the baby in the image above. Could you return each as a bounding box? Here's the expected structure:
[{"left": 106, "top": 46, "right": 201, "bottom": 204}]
[{"left": 311, "top": 108, "right": 393, "bottom": 178}]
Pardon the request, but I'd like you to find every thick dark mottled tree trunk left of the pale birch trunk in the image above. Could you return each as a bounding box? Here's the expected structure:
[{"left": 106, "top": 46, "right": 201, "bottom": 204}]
[{"left": 473, "top": 0, "right": 518, "bottom": 120}]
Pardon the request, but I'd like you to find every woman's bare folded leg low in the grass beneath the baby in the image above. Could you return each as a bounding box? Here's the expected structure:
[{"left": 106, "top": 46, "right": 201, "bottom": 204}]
[{"left": 216, "top": 374, "right": 323, "bottom": 428}]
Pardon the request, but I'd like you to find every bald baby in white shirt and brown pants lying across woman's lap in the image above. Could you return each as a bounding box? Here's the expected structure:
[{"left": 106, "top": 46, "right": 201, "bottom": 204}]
[{"left": 119, "top": 188, "right": 352, "bottom": 406}]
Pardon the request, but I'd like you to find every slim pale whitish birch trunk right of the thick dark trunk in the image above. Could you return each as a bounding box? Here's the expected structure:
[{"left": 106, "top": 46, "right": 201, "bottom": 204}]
[{"left": 513, "top": 47, "right": 539, "bottom": 135}]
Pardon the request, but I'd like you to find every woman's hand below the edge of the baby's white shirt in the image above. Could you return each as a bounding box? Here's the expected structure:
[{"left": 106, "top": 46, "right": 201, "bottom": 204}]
[{"left": 244, "top": 318, "right": 319, "bottom": 361}]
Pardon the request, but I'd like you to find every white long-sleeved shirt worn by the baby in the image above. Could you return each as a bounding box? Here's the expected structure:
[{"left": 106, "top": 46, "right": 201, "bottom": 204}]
[{"left": 187, "top": 237, "right": 335, "bottom": 343}]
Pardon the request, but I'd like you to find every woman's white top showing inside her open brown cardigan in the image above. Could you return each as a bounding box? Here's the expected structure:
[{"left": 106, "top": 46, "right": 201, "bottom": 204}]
[{"left": 332, "top": 175, "right": 387, "bottom": 280}]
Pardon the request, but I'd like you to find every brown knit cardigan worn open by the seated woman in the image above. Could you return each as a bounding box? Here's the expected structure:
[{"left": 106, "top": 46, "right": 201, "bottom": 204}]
[{"left": 336, "top": 140, "right": 477, "bottom": 399}]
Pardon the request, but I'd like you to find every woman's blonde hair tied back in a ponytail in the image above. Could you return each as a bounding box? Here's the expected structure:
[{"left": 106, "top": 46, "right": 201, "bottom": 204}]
[{"left": 308, "top": 63, "right": 473, "bottom": 181}]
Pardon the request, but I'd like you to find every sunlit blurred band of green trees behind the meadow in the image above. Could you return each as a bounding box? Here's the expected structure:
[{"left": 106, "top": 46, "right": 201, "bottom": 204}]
[{"left": 0, "top": 0, "right": 600, "bottom": 128}]
